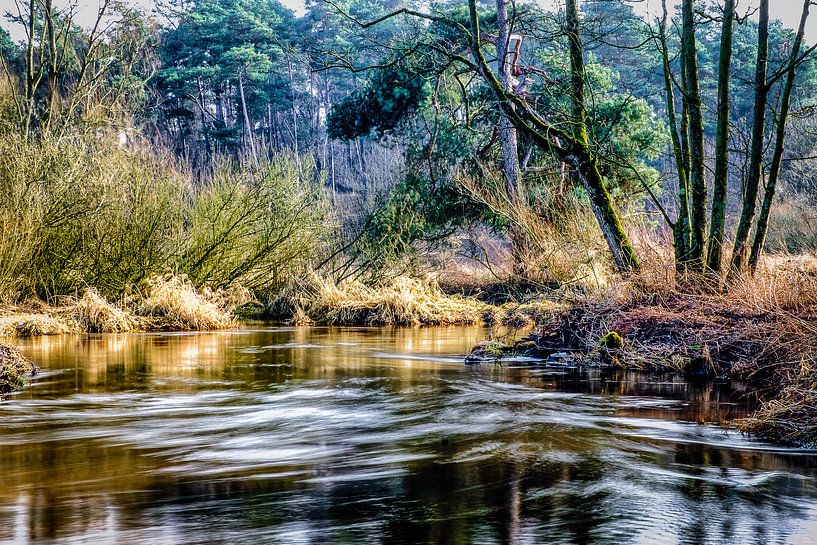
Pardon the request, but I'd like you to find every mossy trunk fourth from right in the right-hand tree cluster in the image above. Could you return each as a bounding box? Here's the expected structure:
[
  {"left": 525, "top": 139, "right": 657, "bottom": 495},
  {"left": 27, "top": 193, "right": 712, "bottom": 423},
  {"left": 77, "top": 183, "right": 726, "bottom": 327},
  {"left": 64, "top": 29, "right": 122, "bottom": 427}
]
[{"left": 681, "top": 0, "right": 706, "bottom": 272}]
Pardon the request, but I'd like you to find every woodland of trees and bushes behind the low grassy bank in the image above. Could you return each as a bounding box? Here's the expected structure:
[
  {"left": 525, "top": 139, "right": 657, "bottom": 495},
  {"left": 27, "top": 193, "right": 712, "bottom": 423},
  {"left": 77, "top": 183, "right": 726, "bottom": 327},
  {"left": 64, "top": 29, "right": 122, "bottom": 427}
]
[{"left": 0, "top": 0, "right": 817, "bottom": 300}]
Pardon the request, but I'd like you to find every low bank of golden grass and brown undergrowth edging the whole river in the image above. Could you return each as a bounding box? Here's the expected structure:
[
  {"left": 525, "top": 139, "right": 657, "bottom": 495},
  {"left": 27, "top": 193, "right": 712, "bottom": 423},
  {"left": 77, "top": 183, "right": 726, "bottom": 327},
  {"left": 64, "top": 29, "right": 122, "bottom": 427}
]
[{"left": 0, "top": 267, "right": 817, "bottom": 445}]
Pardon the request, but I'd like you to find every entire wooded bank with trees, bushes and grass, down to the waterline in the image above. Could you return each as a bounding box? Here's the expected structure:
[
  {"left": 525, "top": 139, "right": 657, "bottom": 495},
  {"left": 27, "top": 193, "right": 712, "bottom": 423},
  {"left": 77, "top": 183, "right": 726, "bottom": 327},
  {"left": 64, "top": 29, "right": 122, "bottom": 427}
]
[{"left": 0, "top": 0, "right": 817, "bottom": 444}]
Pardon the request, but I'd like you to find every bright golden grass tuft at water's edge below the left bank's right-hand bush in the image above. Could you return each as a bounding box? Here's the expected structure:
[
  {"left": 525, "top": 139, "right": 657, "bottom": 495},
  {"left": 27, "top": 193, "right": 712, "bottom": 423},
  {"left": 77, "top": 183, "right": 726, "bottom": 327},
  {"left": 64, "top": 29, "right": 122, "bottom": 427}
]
[{"left": 135, "top": 276, "right": 238, "bottom": 331}]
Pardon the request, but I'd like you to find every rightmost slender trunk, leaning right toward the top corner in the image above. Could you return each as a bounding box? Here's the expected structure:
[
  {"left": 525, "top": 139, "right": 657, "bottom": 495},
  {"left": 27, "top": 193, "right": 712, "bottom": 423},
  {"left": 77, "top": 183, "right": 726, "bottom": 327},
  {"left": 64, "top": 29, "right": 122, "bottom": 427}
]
[{"left": 749, "top": 0, "right": 811, "bottom": 272}]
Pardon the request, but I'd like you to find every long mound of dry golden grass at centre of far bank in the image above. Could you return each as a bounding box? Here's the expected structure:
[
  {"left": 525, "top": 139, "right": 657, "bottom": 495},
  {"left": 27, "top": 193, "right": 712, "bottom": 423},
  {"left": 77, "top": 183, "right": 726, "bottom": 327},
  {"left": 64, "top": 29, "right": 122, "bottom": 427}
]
[{"left": 272, "top": 275, "right": 495, "bottom": 325}]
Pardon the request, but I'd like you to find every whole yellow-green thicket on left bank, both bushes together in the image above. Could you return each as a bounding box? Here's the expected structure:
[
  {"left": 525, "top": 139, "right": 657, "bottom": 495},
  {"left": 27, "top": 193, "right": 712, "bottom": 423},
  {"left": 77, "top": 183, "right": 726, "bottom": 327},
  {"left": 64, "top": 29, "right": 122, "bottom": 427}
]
[{"left": 0, "top": 133, "right": 326, "bottom": 301}]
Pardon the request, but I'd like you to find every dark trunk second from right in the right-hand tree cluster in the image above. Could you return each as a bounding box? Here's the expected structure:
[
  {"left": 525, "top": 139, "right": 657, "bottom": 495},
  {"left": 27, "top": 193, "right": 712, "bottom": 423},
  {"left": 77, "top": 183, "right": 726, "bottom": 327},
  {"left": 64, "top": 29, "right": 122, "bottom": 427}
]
[{"left": 732, "top": 0, "right": 769, "bottom": 273}]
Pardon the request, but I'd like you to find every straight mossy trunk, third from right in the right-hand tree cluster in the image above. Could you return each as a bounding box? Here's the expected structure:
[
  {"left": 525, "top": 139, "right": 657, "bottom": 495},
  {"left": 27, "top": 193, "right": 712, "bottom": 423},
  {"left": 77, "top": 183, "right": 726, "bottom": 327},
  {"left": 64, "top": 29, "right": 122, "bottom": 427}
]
[{"left": 706, "top": 0, "right": 735, "bottom": 277}]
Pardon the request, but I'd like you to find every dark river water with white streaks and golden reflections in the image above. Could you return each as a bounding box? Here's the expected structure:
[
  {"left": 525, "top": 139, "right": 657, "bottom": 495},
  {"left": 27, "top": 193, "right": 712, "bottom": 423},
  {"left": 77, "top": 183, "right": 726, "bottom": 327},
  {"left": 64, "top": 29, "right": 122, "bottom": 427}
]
[{"left": 0, "top": 328, "right": 817, "bottom": 544}]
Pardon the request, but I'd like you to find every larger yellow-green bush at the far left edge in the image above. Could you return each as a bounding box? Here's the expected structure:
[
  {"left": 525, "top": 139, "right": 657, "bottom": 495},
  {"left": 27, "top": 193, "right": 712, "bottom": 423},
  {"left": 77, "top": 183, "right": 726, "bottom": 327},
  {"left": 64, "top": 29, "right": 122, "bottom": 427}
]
[{"left": 0, "top": 134, "right": 184, "bottom": 298}]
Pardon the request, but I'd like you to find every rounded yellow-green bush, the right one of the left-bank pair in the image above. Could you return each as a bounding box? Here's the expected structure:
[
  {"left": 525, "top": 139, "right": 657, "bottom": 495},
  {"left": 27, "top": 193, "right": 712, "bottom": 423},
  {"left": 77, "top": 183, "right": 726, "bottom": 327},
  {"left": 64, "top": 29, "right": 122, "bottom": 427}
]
[{"left": 179, "top": 155, "right": 326, "bottom": 289}]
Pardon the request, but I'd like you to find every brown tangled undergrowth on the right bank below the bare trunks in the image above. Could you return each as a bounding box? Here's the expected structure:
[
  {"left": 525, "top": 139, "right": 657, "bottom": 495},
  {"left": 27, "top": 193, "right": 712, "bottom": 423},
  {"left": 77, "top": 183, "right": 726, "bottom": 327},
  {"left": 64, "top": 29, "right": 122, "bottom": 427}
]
[{"left": 528, "top": 256, "right": 817, "bottom": 445}]
